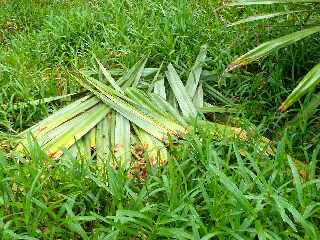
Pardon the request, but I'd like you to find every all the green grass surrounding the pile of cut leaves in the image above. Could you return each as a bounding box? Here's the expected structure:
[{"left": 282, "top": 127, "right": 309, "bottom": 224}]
[{"left": 0, "top": 0, "right": 320, "bottom": 239}]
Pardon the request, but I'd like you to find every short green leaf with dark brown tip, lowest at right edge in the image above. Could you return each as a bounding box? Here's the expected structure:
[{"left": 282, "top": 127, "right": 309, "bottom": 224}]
[{"left": 280, "top": 63, "right": 320, "bottom": 111}]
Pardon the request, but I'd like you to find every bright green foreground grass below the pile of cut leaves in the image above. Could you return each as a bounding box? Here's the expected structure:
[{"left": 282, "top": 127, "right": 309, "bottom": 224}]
[{"left": 0, "top": 129, "right": 320, "bottom": 239}]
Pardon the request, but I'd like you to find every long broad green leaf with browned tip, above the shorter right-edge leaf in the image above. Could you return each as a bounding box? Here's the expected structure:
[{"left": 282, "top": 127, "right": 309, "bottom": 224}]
[{"left": 226, "top": 26, "right": 320, "bottom": 71}]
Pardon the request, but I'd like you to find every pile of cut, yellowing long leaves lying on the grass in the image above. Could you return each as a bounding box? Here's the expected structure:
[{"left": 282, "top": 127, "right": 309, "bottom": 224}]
[{"left": 18, "top": 45, "right": 272, "bottom": 169}]
